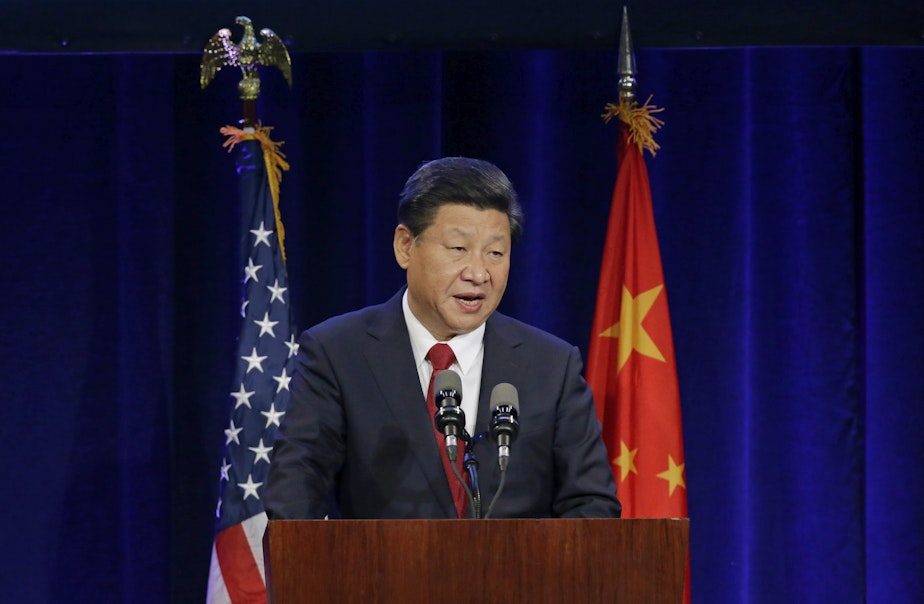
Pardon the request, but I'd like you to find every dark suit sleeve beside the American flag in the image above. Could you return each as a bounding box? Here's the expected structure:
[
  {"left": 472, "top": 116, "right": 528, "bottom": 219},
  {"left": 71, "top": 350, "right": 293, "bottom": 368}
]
[{"left": 265, "top": 331, "right": 345, "bottom": 520}]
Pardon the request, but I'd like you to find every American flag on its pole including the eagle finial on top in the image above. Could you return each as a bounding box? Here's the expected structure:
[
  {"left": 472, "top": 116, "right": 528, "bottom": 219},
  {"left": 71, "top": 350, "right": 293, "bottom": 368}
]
[{"left": 200, "top": 17, "right": 298, "bottom": 604}]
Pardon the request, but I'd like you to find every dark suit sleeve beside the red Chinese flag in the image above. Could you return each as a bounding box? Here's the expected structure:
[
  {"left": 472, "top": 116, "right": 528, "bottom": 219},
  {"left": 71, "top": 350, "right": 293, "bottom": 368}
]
[{"left": 552, "top": 348, "right": 622, "bottom": 518}]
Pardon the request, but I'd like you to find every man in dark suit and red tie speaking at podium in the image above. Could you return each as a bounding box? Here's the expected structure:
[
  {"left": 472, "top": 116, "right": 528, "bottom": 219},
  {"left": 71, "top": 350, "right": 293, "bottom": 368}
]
[{"left": 265, "top": 158, "right": 621, "bottom": 519}]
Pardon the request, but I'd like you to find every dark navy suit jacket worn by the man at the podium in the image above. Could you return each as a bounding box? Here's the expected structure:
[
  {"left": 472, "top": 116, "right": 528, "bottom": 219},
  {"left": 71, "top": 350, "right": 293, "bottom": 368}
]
[{"left": 265, "top": 291, "right": 620, "bottom": 519}]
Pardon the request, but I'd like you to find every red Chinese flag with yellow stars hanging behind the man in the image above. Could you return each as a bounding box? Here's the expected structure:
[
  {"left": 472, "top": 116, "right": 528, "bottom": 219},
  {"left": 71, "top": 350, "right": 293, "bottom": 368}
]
[{"left": 586, "top": 124, "right": 689, "bottom": 602}]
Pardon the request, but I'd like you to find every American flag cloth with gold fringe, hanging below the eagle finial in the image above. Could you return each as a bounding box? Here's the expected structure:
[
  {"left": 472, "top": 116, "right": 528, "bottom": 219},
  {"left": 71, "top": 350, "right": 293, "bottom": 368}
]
[{"left": 207, "top": 134, "right": 298, "bottom": 604}]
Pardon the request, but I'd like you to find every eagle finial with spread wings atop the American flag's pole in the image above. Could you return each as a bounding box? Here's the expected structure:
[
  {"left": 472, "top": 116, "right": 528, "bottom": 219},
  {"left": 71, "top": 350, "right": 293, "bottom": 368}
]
[{"left": 199, "top": 16, "right": 292, "bottom": 126}]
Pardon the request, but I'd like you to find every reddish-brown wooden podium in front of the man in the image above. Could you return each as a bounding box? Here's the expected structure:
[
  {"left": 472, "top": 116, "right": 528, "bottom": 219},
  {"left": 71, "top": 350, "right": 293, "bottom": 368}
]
[{"left": 263, "top": 518, "right": 690, "bottom": 604}]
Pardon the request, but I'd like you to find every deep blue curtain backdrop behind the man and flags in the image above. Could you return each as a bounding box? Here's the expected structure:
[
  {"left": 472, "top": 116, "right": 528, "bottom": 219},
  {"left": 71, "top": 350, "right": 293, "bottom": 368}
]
[{"left": 0, "top": 47, "right": 924, "bottom": 604}]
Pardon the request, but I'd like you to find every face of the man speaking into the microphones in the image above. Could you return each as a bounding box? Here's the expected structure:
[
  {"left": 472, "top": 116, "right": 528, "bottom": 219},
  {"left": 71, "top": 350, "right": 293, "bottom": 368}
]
[{"left": 394, "top": 204, "right": 511, "bottom": 341}]
